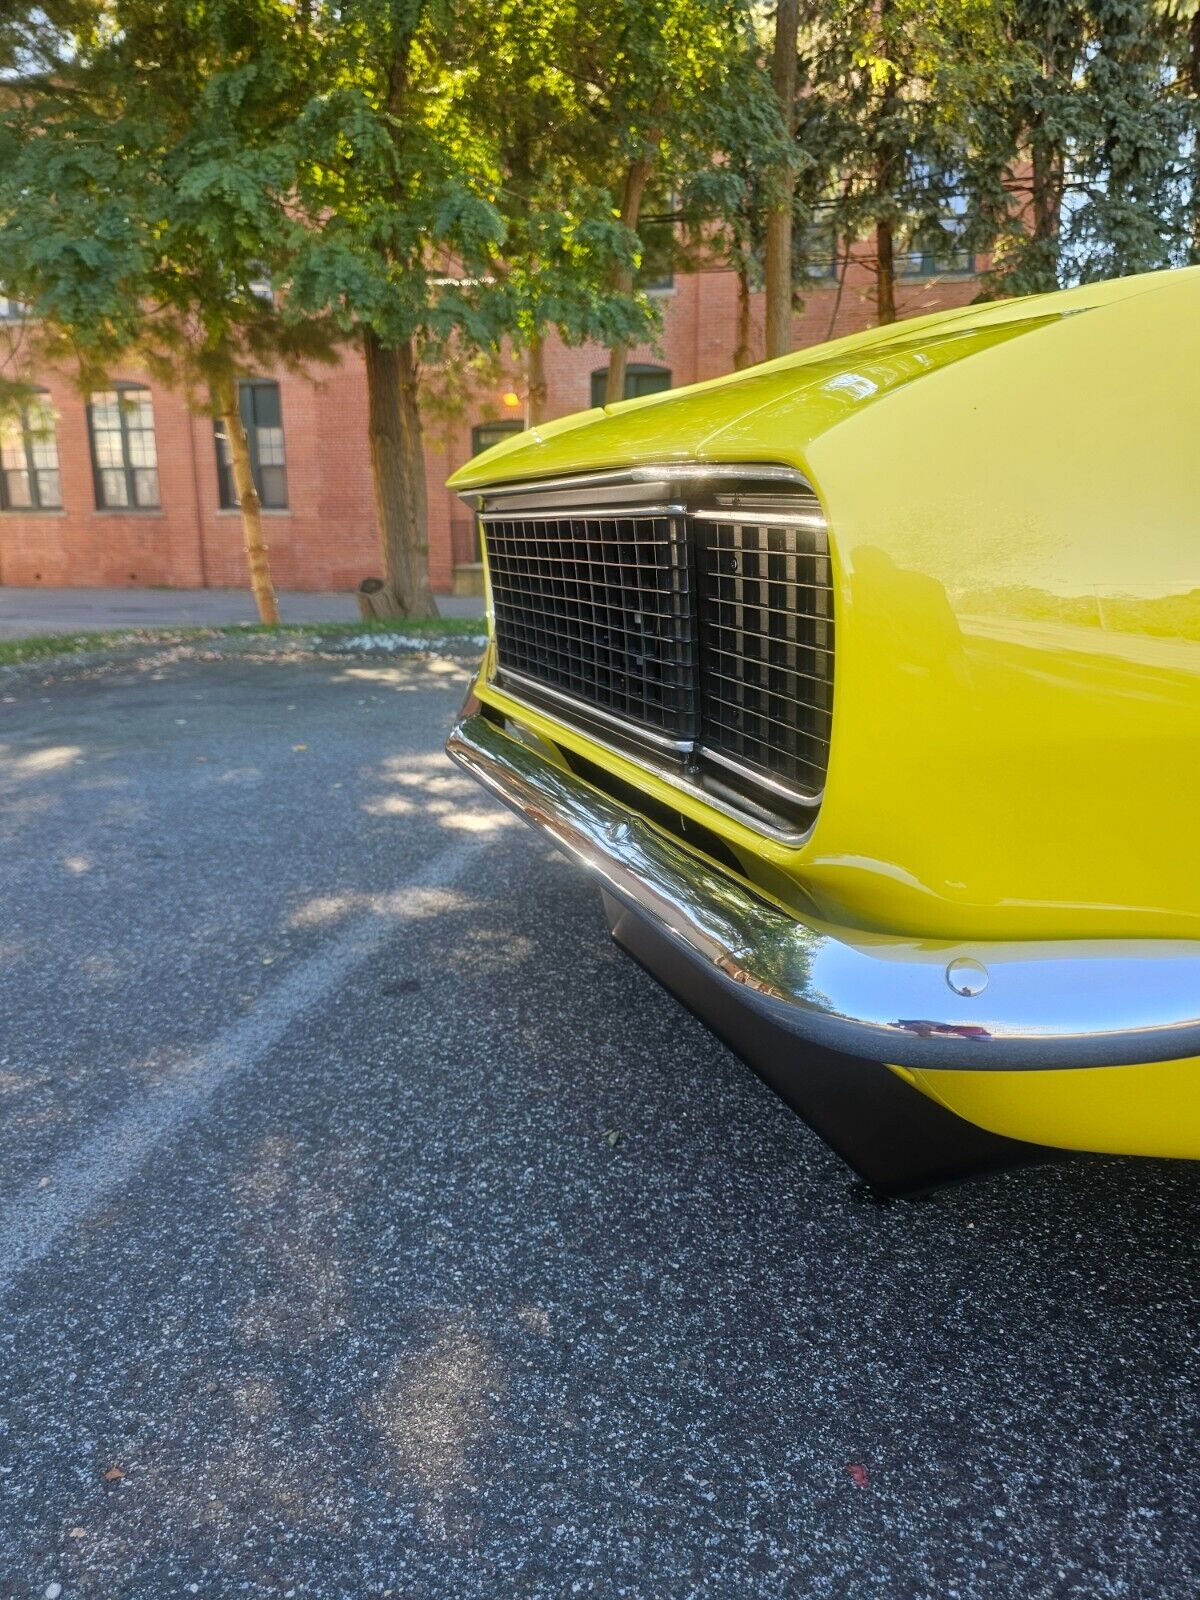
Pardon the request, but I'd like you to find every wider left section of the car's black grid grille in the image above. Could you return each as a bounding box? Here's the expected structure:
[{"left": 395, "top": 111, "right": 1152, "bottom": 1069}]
[{"left": 486, "top": 512, "right": 699, "bottom": 742}]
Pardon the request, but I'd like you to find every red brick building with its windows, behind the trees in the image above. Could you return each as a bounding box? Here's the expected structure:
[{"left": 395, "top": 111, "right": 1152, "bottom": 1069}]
[{"left": 0, "top": 256, "right": 978, "bottom": 592}]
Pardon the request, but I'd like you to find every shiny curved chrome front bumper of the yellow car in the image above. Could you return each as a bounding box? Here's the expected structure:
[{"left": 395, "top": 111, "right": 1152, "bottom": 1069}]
[{"left": 446, "top": 710, "right": 1200, "bottom": 1070}]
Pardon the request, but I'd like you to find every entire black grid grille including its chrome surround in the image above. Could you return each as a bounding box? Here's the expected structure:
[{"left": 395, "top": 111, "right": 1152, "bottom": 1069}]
[{"left": 478, "top": 464, "right": 834, "bottom": 838}]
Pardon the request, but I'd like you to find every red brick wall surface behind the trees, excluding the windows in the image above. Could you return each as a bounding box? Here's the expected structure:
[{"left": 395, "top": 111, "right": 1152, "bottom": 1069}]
[{"left": 0, "top": 261, "right": 978, "bottom": 590}]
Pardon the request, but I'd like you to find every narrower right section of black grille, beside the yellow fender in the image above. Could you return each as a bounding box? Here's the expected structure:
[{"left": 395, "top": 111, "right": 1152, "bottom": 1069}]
[{"left": 699, "top": 514, "right": 834, "bottom": 795}]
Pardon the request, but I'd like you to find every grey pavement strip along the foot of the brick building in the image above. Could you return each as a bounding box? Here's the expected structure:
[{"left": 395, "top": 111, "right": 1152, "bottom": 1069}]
[{"left": 0, "top": 586, "right": 483, "bottom": 638}]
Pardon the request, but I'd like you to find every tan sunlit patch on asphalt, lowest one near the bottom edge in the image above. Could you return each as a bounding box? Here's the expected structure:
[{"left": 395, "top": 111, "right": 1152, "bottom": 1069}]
[{"left": 366, "top": 1326, "right": 506, "bottom": 1536}]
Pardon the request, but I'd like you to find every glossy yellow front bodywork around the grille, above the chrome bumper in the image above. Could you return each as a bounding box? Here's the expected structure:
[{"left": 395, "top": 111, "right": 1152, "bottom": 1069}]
[{"left": 451, "top": 269, "right": 1200, "bottom": 938}]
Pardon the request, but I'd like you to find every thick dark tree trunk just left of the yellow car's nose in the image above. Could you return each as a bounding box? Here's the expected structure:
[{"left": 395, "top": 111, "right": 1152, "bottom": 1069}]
[{"left": 363, "top": 328, "right": 437, "bottom": 618}]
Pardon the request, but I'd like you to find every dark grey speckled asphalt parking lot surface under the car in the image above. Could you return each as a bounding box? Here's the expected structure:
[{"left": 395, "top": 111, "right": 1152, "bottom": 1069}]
[{"left": 0, "top": 650, "right": 1200, "bottom": 1600}]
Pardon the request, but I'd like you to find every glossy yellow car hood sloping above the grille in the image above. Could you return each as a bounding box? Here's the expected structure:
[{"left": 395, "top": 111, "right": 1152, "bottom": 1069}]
[{"left": 450, "top": 274, "right": 1170, "bottom": 494}]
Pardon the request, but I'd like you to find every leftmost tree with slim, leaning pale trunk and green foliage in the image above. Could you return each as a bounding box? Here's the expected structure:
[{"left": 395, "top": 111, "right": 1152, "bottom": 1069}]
[{"left": 0, "top": 0, "right": 334, "bottom": 622}]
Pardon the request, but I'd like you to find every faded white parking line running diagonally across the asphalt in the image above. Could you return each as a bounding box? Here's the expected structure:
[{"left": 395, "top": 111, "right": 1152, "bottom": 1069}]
[{"left": 0, "top": 840, "right": 483, "bottom": 1301}]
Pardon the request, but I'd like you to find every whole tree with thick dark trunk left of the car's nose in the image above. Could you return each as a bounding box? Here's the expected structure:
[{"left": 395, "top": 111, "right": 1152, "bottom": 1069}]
[{"left": 288, "top": 0, "right": 668, "bottom": 616}]
